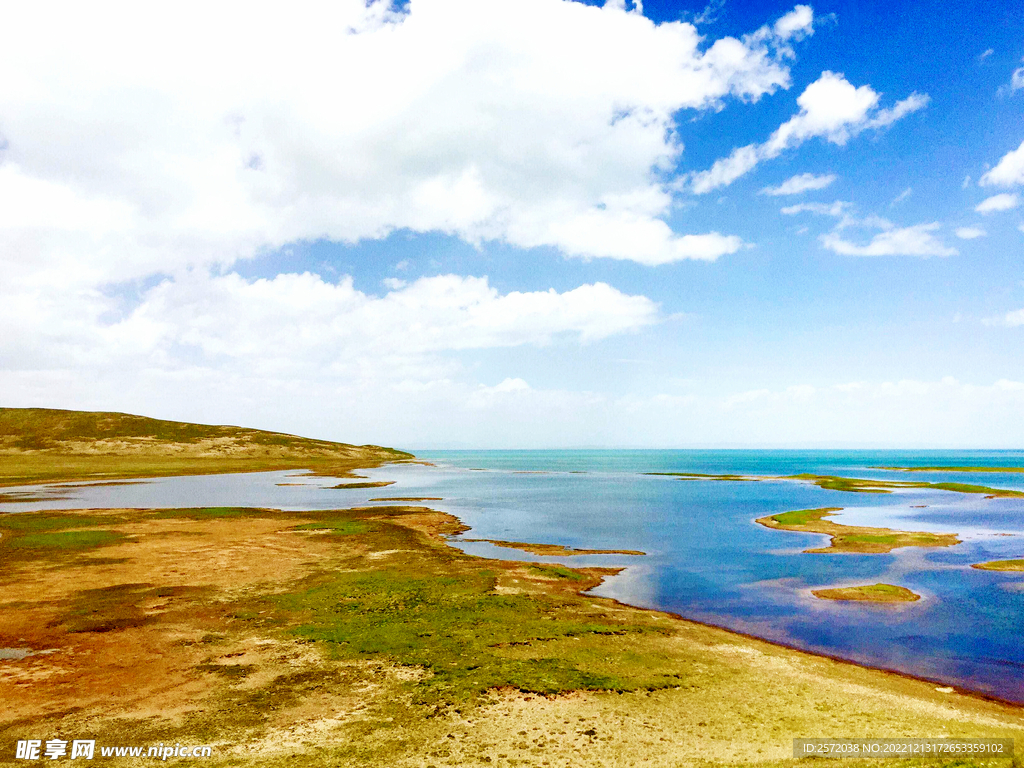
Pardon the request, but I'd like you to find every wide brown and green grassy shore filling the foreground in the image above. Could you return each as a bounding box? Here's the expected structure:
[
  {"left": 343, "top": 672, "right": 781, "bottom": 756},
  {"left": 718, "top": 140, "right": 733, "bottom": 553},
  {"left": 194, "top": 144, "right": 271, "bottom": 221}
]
[{"left": 0, "top": 506, "right": 1024, "bottom": 768}]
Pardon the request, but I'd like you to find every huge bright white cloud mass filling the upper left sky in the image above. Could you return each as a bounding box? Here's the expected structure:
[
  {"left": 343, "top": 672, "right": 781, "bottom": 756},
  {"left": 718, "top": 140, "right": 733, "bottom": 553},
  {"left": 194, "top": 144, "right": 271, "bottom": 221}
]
[{"left": 0, "top": 0, "right": 813, "bottom": 283}]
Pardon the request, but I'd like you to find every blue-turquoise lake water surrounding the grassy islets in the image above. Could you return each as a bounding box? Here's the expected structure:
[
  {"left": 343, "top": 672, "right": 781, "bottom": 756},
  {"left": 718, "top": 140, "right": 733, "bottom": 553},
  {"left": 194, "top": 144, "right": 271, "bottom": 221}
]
[{"left": 6, "top": 451, "right": 1024, "bottom": 701}]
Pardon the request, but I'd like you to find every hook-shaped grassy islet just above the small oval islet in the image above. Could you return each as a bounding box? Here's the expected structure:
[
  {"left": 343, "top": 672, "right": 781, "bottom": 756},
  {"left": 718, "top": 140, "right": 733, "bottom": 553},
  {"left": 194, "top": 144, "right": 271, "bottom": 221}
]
[{"left": 757, "top": 507, "right": 961, "bottom": 554}]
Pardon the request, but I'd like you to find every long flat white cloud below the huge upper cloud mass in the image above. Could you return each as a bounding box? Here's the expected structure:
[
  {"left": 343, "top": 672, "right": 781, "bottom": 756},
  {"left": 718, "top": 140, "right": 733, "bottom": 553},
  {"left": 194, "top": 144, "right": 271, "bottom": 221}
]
[{"left": 130, "top": 272, "right": 658, "bottom": 366}]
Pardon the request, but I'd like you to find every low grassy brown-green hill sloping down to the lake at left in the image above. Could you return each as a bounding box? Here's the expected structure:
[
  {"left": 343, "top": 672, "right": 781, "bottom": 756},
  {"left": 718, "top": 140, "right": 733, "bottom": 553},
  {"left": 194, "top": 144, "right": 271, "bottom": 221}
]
[{"left": 0, "top": 408, "right": 413, "bottom": 486}]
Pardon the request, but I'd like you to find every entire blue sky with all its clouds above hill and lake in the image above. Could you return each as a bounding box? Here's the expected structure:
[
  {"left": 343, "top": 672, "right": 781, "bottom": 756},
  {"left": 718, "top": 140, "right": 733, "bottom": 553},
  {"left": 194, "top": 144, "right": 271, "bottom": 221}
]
[{"left": 0, "top": 0, "right": 1024, "bottom": 449}]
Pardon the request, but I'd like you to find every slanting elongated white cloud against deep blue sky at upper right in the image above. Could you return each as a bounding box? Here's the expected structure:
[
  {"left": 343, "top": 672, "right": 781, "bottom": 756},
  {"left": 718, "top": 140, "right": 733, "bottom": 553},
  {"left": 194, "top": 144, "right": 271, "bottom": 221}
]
[{"left": 690, "top": 72, "right": 929, "bottom": 195}]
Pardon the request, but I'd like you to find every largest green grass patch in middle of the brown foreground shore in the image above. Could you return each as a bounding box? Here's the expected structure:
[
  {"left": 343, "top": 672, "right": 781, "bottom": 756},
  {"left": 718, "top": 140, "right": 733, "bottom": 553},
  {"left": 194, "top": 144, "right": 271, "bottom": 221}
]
[{"left": 275, "top": 565, "right": 678, "bottom": 703}]
